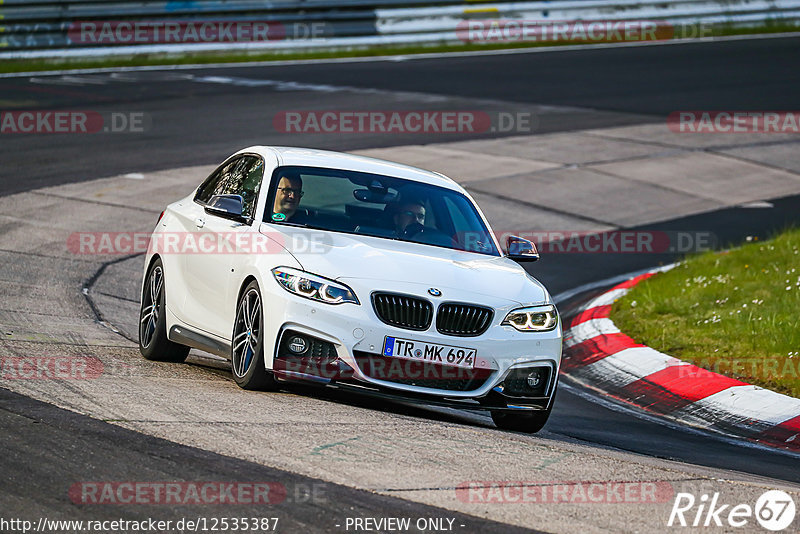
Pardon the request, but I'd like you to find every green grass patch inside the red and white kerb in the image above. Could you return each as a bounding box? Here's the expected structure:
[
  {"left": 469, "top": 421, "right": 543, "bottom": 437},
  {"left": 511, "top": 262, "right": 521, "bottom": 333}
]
[{"left": 611, "top": 229, "right": 800, "bottom": 397}]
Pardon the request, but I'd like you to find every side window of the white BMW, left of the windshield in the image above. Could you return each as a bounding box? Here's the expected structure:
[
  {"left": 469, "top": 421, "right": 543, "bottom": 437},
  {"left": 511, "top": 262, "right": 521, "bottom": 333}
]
[{"left": 194, "top": 156, "right": 264, "bottom": 221}]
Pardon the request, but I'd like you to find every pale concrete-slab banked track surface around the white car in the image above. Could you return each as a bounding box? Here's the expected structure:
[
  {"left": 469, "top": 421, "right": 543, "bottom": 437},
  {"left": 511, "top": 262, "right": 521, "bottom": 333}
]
[{"left": 0, "top": 124, "right": 800, "bottom": 532}]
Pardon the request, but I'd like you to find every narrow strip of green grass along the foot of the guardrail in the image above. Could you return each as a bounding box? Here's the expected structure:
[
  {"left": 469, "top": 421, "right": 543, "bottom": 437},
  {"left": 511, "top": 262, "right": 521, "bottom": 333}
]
[{"left": 0, "top": 21, "right": 798, "bottom": 73}]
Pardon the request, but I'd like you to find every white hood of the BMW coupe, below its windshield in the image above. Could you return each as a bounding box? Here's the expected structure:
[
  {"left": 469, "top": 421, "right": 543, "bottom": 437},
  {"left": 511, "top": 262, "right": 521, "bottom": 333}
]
[{"left": 262, "top": 226, "right": 550, "bottom": 305}]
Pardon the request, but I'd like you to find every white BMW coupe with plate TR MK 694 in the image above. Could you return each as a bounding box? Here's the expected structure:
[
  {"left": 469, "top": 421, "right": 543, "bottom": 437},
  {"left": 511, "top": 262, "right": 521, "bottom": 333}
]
[{"left": 139, "top": 146, "right": 562, "bottom": 432}]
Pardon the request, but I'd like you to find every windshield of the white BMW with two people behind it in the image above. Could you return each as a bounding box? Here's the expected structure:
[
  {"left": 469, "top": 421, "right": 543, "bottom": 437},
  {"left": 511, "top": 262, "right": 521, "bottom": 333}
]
[{"left": 264, "top": 166, "right": 499, "bottom": 256}]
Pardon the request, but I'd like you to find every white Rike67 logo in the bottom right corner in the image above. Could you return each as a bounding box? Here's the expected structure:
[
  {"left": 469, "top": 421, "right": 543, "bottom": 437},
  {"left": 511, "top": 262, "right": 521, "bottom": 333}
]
[{"left": 667, "top": 490, "right": 796, "bottom": 532}]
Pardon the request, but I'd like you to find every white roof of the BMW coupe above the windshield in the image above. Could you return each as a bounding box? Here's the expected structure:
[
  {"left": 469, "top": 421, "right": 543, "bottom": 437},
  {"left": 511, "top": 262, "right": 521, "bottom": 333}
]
[{"left": 240, "top": 146, "right": 462, "bottom": 191}]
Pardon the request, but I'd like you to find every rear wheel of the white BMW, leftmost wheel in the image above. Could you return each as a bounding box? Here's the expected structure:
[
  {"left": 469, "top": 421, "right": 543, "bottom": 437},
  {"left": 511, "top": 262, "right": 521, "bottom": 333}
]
[{"left": 139, "top": 258, "right": 189, "bottom": 363}]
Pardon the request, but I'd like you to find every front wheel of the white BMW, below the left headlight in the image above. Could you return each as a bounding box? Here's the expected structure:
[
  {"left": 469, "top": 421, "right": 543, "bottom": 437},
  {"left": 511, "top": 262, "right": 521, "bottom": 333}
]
[{"left": 231, "top": 280, "right": 277, "bottom": 390}]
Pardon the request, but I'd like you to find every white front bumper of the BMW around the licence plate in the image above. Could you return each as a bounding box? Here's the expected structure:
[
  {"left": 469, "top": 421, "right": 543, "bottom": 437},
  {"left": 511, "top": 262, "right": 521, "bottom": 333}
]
[{"left": 265, "top": 282, "right": 562, "bottom": 411}]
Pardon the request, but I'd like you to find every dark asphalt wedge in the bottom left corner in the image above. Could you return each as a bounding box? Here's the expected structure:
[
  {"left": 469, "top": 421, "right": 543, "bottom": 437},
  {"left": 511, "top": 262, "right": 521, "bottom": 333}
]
[{"left": 0, "top": 389, "right": 535, "bottom": 533}]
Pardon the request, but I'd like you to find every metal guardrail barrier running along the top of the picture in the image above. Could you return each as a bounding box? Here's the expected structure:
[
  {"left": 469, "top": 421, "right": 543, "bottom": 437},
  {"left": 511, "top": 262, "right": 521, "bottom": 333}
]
[{"left": 0, "top": 0, "right": 800, "bottom": 58}]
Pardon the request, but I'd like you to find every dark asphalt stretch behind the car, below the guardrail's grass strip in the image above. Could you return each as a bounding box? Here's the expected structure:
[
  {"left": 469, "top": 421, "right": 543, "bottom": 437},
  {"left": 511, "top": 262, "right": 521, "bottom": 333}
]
[{"left": 0, "top": 37, "right": 800, "bottom": 194}]
